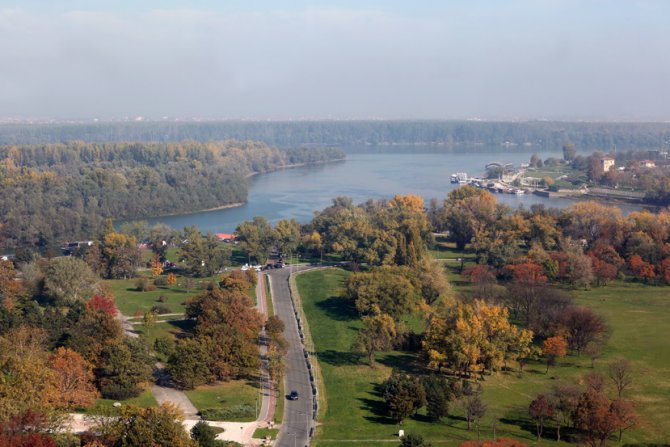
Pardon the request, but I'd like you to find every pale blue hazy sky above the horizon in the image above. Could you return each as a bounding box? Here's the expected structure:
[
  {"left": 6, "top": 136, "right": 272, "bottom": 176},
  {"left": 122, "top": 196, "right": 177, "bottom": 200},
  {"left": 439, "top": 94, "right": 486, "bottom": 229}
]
[{"left": 0, "top": 0, "right": 670, "bottom": 121}]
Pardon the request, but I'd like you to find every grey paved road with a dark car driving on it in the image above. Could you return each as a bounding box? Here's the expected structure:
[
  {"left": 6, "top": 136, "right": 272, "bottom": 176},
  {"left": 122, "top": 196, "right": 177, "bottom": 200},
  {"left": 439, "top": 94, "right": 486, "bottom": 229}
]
[{"left": 268, "top": 268, "right": 314, "bottom": 447}]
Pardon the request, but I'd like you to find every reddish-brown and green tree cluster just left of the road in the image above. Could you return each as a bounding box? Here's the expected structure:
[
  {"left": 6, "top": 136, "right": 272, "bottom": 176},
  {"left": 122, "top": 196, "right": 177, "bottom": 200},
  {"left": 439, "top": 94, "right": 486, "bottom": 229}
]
[{"left": 167, "top": 271, "right": 264, "bottom": 389}]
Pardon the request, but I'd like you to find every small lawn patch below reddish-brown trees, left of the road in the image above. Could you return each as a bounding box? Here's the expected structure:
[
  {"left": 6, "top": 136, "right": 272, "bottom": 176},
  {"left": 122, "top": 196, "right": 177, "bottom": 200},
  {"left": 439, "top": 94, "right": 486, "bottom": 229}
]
[{"left": 185, "top": 379, "right": 260, "bottom": 422}]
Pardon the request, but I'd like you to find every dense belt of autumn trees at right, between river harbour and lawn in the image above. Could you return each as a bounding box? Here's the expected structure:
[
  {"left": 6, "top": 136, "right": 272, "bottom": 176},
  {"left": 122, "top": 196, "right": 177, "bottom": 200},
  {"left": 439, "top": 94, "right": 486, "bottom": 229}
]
[{"left": 438, "top": 186, "right": 670, "bottom": 287}]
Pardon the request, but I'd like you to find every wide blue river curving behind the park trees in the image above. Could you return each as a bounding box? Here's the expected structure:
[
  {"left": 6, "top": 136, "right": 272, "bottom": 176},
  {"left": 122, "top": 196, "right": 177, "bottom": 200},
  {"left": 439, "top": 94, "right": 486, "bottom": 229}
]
[{"left": 146, "top": 152, "right": 638, "bottom": 233}]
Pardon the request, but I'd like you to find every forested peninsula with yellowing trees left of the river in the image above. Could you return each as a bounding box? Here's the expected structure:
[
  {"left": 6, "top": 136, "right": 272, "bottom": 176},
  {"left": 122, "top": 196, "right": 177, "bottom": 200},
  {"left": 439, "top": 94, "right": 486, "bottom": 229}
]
[{"left": 0, "top": 140, "right": 344, "bottom": 250}]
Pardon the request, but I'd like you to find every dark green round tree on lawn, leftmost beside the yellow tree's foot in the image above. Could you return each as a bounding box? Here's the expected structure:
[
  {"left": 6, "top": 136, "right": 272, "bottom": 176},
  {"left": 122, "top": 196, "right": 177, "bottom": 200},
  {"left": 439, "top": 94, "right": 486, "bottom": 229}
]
[{"left": 382, "top": 370, "right": 426, "bottom": 423}]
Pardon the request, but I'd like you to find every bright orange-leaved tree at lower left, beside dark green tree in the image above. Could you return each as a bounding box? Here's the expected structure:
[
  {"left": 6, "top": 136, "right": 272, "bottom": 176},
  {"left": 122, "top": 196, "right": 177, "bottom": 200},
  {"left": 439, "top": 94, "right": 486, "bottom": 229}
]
[{"left": 49, "top": 347, "right": 98, "bottom": 409}]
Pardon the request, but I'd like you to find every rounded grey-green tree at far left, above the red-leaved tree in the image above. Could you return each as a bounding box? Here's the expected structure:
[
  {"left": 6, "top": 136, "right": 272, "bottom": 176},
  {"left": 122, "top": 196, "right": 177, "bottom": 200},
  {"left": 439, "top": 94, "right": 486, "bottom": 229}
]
[{"left": 44, "top": 256, "right": 98, "bottom": 302}]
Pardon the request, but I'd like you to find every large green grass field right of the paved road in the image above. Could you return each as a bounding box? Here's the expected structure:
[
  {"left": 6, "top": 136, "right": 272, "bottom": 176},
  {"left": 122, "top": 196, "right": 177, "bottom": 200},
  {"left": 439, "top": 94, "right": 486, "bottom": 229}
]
[{"left": 297, "top": 269, "right": 670, "bottom": 446}]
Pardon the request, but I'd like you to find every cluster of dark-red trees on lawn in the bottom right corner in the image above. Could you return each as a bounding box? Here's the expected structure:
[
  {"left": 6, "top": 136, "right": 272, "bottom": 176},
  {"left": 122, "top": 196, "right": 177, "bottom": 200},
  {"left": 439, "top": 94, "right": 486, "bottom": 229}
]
[{"left": 528, "top": 359, "right": 639, "bottom": 447}]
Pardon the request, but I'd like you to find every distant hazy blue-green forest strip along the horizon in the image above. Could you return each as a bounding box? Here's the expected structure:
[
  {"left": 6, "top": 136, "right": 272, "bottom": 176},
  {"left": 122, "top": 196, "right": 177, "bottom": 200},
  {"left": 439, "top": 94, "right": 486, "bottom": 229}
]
[{"left": 0, "top": 120, "right": 670, "bottom": 151}]
